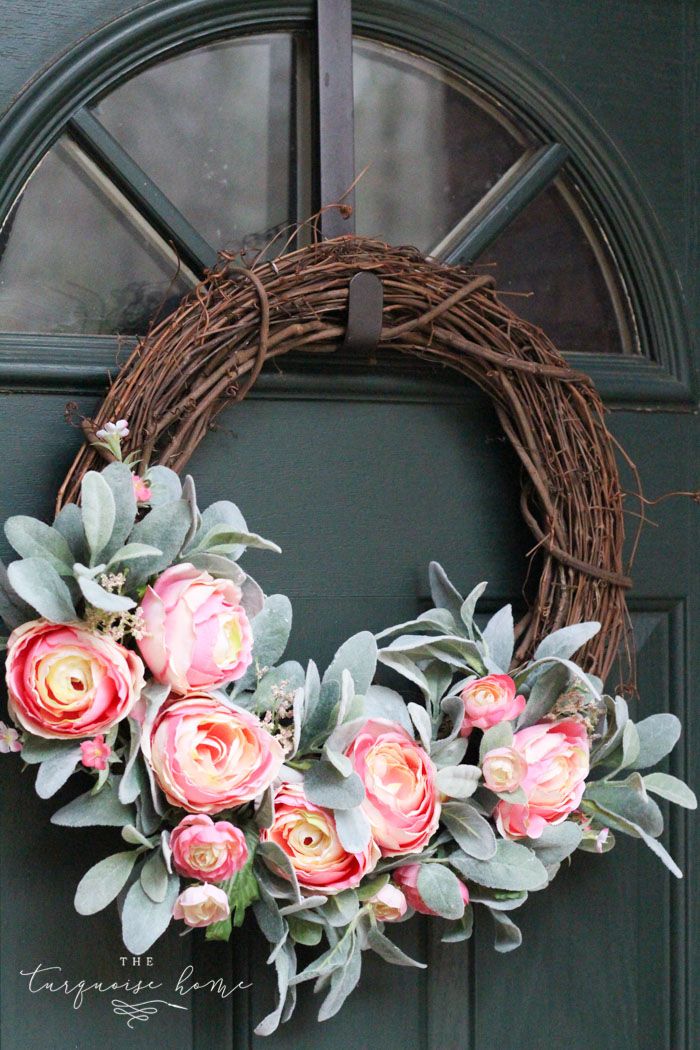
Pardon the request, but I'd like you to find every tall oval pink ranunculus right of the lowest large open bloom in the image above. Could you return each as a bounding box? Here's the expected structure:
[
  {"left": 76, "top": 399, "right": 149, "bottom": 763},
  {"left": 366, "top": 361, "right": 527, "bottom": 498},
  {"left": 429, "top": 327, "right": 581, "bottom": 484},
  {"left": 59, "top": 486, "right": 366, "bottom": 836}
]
[{"left": 345, "top": 718, "right": 440, "bottom": 856}]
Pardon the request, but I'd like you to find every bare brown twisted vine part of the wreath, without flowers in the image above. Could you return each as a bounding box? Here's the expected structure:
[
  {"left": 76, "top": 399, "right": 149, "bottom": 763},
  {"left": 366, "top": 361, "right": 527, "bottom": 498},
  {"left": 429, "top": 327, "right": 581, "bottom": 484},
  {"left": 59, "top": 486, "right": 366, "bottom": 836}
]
[{"left": 58, "top": 237, "right": 631, "bottom": 678}]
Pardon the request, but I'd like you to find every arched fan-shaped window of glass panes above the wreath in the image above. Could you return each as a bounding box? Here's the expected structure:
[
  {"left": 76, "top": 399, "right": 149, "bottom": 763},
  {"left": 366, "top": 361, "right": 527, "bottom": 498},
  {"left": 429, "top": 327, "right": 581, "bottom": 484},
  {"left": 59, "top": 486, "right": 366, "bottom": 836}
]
[{"left": 0, "top": 30, "right": 640, "bottom": 354}]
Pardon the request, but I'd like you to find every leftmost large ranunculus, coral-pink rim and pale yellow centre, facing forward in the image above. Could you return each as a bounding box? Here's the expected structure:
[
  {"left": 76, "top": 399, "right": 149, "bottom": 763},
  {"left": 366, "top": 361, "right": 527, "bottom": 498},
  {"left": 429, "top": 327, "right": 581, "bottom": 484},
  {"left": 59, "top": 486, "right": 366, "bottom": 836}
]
[{"left": 5, "top": 620, "right": 144, "bottom": 737}]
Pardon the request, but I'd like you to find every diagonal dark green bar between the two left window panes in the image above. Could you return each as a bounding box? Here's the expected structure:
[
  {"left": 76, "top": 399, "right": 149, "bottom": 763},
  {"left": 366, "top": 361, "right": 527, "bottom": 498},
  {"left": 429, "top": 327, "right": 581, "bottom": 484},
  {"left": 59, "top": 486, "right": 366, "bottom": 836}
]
[{"left": 68, "top": 109, "right": 216, "bottom": 275}]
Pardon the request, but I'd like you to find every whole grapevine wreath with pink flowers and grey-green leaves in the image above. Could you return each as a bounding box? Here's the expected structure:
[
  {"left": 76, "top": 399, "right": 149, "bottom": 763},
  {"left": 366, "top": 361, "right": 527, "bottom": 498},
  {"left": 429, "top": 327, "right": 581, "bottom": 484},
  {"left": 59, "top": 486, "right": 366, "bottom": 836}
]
[{"left": 0, "top": 237, "right": 696, "bottom": 1034}]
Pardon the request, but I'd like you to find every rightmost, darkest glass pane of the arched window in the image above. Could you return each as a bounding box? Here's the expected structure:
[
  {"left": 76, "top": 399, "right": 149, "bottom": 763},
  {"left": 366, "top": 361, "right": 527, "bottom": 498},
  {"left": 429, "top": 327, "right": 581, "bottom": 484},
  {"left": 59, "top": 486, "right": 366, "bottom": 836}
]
[{"left": 479, "top": 186, "right": 633, "bottom": 354}]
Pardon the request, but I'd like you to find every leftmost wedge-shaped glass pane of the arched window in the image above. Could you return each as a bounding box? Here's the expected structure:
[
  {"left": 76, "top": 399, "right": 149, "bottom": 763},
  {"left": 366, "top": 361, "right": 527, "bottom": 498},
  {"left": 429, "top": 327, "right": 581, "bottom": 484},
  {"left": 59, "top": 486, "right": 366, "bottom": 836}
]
[{"left": 0, "top": 140, "right": 191, "bottom": 335}]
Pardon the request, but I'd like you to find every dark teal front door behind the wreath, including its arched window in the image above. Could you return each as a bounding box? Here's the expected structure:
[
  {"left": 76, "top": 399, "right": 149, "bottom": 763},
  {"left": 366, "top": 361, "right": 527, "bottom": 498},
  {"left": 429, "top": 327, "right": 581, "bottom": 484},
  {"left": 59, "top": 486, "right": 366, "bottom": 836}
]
[{"left": 0, "top": 0, "right": 700, "bottom": 1050}]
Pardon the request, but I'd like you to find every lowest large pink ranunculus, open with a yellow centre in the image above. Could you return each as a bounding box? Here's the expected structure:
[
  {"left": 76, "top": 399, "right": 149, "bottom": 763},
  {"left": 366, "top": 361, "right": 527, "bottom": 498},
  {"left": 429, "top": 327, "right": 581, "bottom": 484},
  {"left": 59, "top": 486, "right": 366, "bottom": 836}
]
[{"left": 260, "top": 783, "right": 380, "bottom": 894}]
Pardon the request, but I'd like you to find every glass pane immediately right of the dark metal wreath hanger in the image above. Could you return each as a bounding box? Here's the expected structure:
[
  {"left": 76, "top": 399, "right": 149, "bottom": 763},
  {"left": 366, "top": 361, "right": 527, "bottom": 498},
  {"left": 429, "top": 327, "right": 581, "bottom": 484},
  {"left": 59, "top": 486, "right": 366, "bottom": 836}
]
[{"left": 354, "top": 40, "right": 527, "bottom": 252}]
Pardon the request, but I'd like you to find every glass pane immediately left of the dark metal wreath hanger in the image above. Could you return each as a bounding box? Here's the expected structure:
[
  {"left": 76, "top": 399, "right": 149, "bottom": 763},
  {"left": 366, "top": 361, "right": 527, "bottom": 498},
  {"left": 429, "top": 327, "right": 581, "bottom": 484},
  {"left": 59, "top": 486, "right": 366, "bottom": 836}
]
[{"left": 96, "top": 34, "right": 296, "bottom": 250}]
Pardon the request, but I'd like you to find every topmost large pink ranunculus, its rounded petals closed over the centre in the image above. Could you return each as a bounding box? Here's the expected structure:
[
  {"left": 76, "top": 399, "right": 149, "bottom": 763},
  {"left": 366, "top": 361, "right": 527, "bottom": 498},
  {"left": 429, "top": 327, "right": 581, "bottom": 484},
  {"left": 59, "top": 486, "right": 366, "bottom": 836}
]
[{"left": 139, "top": 563, "right": 253, "bottom": 693}]
